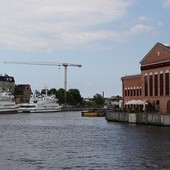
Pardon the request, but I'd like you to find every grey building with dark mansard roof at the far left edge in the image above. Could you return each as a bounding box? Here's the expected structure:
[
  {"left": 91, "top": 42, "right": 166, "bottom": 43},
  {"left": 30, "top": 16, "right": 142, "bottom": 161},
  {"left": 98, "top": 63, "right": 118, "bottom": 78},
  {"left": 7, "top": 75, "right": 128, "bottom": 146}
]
[{"left": 0, "top": 74, "right": 15, "bottom": 94}]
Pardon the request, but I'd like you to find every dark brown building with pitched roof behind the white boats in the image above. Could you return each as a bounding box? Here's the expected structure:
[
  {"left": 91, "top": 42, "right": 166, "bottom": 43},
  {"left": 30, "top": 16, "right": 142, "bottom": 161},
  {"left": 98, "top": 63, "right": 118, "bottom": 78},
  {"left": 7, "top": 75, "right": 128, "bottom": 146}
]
[{"left": 14, "top": 84, "right": 32, "bottom": 104}]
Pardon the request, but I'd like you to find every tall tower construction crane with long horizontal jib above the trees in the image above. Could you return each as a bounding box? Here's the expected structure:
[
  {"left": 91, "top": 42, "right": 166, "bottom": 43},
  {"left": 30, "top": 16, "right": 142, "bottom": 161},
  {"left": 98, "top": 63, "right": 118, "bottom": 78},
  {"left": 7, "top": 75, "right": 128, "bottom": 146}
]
[{"left": 4, "top": 61, "right": 82, "bottom": 104}]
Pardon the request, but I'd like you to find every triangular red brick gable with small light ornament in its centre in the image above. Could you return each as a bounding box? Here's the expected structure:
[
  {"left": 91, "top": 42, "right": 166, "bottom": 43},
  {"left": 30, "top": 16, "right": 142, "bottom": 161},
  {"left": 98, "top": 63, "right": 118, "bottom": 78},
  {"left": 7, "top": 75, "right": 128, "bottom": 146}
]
[{"left": 140, "top": 43, "right": 170, "bottom": 66}]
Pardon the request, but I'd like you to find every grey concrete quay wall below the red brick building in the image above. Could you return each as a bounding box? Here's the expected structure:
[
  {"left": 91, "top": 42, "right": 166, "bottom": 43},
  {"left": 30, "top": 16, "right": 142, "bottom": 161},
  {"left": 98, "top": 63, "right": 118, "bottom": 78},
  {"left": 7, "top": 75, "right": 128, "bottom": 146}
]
[{"left": 105, "top": 112, "right": 170, "bottom": 126}]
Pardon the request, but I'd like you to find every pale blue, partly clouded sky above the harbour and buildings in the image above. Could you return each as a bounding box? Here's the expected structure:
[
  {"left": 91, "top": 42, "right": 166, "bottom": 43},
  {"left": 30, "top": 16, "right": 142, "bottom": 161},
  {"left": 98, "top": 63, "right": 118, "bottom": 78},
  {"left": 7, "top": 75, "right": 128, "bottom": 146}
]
[{"left": 0, "top": 0, "right": 170, "bottom": 98}]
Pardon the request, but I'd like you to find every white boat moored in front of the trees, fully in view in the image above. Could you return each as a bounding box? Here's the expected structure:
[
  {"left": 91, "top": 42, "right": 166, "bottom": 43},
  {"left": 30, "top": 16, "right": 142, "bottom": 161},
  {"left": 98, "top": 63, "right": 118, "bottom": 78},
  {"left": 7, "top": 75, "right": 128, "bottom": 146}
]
[{"left": 18, "top": 91, "right": 62, "bottom": 113}]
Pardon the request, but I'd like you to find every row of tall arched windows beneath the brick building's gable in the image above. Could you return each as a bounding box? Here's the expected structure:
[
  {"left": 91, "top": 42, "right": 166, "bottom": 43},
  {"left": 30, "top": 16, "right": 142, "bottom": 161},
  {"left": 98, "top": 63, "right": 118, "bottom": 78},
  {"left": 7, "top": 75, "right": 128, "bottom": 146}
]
[{"left": 144, "top": 72, "right": 170, "bottom": 96}]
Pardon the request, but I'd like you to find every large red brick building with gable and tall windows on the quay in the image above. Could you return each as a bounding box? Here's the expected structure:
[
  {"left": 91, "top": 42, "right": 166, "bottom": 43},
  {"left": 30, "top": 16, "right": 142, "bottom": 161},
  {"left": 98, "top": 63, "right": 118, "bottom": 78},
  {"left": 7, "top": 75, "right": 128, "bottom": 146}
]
[{"left": 121, "top": 43, "right": 170, "bottom": 114}]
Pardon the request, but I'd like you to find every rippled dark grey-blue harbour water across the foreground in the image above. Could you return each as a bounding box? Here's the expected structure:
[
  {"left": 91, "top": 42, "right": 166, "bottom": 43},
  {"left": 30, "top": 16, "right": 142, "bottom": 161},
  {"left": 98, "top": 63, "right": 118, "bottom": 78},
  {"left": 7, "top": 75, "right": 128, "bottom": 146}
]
[{"left": 0, "top": 112, "right": 170, "bottom": 170}]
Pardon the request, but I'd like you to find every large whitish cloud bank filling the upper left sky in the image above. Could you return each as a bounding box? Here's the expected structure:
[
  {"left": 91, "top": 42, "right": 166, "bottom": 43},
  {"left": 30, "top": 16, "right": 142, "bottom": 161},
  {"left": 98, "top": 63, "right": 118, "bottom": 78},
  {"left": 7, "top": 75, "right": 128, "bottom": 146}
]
[{"left": 0, "top": 0, "right": 151, "bottom": 51}]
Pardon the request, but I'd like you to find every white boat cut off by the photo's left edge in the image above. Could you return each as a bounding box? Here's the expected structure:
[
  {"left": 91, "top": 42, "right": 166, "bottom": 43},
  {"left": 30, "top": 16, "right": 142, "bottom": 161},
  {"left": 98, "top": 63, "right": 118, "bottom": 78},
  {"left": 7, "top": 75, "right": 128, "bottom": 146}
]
[{"left": 0, "top": 92, "right": 18, "bottom": 114}]
